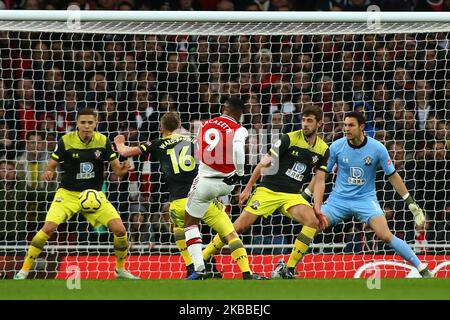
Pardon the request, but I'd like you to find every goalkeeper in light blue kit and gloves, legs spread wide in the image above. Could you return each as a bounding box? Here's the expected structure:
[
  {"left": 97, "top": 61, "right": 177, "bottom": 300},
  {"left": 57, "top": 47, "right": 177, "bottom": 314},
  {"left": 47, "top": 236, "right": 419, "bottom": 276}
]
[{"left": 312, "top": 112, "right": 433, "bottom": 278}]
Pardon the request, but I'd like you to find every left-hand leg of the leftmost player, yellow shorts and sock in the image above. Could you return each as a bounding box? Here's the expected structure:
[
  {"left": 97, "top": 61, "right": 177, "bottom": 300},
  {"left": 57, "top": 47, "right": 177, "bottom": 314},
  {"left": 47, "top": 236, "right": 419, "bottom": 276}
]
[{"left": 14, "top": 188, "right": 78, "bottom": 280}]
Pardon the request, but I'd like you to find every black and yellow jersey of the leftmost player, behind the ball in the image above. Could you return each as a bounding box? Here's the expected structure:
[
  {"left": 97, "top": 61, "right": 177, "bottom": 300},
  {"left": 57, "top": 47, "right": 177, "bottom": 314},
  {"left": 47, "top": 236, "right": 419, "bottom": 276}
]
[{"left": 51, "top": 131, "right": 117, "bottom": 191}]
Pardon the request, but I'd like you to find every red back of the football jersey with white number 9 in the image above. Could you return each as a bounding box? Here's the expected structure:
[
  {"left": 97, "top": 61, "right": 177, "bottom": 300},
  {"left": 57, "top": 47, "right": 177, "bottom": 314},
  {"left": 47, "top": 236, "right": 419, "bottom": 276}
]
[{"left": 197, "top": 115, "right": 241, "bottom": 173}]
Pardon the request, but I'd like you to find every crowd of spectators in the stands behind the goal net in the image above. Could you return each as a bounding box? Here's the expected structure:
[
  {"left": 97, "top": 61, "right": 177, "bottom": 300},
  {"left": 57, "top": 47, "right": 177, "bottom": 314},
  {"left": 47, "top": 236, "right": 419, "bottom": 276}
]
[{"left": 0, "top": 0, "right": 450, "bottom": 253}]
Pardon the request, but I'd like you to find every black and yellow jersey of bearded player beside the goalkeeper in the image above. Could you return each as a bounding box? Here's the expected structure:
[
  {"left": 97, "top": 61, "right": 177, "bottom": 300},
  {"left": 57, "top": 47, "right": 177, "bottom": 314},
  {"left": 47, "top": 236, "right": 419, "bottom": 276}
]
[{"left": 261, "top": 130, "right": 330, "bottom": 193}]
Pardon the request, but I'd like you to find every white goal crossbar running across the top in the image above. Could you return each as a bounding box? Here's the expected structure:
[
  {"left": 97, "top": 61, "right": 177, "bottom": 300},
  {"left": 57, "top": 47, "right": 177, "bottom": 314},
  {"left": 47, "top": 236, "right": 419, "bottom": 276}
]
[{"left": 0, "top": 10, "right": 450, "bottom": 35}]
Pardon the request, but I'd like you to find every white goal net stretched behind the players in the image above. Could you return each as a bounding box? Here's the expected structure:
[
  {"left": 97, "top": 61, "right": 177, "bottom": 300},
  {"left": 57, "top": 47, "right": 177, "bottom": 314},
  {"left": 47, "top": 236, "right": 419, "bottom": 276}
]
[{"left": 0, "top": 12, "right": 450, "bottom": 278}]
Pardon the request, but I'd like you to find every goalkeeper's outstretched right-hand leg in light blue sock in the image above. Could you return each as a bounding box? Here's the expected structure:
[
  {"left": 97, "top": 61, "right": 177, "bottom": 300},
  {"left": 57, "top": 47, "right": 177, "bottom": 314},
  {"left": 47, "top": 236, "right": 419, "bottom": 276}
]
[{"left": 369, "top": 215, "right": 433, "bottom": 278}]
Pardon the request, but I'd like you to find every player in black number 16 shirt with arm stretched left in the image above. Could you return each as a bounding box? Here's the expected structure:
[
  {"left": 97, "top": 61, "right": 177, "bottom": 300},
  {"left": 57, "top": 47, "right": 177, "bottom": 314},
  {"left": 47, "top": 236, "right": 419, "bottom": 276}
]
[{"left": 114, "top": 112, "right": 261, "bottom": 280}]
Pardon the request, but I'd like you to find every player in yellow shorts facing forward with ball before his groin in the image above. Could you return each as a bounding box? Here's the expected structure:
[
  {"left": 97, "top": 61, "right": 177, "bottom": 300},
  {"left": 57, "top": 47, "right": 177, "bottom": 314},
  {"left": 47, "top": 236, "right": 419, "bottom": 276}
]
[{"left": 14, "top": 108, "right": 139, "bottom": 280}]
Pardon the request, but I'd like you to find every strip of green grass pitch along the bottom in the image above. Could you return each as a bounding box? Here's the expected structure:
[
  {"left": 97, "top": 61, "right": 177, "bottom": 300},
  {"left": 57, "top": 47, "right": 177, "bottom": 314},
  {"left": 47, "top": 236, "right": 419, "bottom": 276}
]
[{"left": 0, "top": 278, "right": 450, "bottom": 300}]
